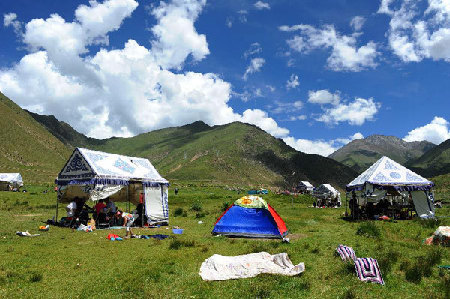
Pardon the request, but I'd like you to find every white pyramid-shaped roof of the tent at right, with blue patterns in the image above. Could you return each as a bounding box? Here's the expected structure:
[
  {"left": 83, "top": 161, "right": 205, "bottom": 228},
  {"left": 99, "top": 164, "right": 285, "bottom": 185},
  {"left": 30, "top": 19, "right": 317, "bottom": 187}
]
[{"left": 347, "top": 157, "right": 434, "bottom": 191}]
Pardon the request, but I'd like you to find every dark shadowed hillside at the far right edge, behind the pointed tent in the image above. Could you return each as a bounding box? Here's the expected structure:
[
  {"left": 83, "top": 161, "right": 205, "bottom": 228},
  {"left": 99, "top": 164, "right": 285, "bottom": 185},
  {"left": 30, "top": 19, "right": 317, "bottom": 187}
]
[{"left": 407, "top": 139, "right": 450, "bottom": 177}]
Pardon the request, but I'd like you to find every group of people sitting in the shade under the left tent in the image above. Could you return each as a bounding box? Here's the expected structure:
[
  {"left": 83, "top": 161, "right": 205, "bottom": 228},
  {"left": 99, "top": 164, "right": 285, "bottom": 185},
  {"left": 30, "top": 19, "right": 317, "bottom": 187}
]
[{"left": 64, "top": 197, "right": 146, "bottom": 236}]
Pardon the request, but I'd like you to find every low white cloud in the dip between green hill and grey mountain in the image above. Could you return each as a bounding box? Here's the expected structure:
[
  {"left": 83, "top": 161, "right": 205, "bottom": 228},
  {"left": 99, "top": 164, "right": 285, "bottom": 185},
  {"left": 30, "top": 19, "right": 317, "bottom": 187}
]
[{"left": 283, "top": 133, "right": 364, "bottom": 157}]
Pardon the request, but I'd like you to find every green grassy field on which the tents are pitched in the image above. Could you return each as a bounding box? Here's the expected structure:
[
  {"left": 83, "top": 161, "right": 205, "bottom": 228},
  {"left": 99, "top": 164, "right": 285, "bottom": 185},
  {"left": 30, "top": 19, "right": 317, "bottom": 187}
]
[{"left": 0, "top": 186, "right": 450, "bottom": 298}]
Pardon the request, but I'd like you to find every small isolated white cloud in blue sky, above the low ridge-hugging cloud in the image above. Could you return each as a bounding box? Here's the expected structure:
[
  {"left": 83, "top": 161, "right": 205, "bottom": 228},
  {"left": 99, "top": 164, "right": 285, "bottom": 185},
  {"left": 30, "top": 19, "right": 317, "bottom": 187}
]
[{"left": 316, "top": 98, "right": 381, "bottom": 126}]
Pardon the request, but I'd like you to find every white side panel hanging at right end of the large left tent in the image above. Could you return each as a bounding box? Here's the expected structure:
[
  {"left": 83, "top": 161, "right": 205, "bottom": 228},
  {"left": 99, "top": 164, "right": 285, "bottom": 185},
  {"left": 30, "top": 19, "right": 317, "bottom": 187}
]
[{"left": 144, "top": 185, "right": 169, "bottom": 222}]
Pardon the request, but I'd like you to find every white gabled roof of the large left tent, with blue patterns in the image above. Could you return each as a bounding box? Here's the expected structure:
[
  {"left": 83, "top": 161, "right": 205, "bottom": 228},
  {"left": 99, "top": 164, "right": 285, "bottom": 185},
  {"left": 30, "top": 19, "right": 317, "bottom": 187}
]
[{"left": 57, "top": 148, "right": 168, "bottom": 185}]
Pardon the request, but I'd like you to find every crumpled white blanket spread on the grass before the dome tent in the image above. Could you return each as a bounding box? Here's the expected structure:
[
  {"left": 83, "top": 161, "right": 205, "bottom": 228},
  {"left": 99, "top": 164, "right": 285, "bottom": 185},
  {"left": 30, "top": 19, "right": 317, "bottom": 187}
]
[{"left": 199, "top": 252, "right": 305, "bottom": 280}]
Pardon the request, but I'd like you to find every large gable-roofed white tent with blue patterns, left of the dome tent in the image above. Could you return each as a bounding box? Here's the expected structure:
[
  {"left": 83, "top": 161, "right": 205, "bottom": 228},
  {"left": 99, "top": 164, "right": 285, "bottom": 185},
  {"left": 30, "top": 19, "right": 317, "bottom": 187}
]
[{"left": 56, "top": 148, "right": 169, "bottom": 223}]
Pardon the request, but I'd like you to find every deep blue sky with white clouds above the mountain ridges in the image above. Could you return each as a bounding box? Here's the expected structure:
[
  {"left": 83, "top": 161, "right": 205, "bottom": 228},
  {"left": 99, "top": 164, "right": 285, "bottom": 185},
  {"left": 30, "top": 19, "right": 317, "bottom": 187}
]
[{"left": 0, "top": 0, "right": 450, "bottom": 156}]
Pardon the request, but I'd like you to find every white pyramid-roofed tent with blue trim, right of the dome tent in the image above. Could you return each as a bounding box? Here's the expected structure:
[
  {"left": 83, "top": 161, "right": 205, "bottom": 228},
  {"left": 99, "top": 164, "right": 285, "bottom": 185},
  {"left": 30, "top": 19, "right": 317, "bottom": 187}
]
[{"left": 347, "top": 157, "right": 434, "bottom": 218}]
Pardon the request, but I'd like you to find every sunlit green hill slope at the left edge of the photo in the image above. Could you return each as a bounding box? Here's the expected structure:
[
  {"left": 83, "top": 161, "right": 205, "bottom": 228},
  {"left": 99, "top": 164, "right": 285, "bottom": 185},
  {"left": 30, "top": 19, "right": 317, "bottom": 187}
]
[{"left": 0, "top": 92, "right": 70, "bottom": 184}]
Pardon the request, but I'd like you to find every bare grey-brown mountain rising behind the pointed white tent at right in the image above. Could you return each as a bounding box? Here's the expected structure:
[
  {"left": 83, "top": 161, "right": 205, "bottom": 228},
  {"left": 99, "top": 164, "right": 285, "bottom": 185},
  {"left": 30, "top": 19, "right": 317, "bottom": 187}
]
[{"left": 329, "top": 135, "right": 435, "bottom": 173}]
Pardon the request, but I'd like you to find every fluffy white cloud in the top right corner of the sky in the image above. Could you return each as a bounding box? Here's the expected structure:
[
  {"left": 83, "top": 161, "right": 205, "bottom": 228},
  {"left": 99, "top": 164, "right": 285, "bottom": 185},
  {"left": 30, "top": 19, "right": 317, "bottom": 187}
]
[{"left": 378, "top": 0, "right": 450, "bottom": 62}]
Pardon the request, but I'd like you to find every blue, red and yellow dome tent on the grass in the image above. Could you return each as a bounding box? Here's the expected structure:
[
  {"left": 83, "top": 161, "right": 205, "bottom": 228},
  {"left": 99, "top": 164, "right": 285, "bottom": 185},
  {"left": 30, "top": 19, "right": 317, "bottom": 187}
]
[{"left": 212, "top": 195, "right": 288, "bottom": 238}]
